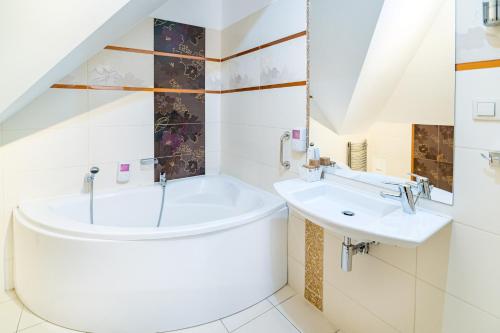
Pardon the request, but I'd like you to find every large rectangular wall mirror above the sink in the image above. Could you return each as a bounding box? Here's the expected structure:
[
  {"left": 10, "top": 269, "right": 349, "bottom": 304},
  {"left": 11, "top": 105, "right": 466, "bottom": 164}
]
[{"left": 309, "top": 0, "right": 455, "bottom": 204}]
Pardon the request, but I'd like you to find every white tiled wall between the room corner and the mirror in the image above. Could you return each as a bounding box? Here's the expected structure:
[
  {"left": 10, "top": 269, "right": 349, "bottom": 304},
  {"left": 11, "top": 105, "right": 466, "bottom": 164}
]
[{"left": 221, "top": 0, "right": 307, "bottom": 191}]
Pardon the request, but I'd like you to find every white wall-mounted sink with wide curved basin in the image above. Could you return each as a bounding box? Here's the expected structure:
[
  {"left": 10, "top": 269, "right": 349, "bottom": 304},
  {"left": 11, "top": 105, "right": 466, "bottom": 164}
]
[{"left": 274, "top": 179, "right": 451, "bottom": 247}]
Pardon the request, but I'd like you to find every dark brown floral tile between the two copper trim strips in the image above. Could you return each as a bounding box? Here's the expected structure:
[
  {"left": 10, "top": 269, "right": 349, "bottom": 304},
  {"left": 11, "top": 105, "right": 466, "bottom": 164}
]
[{"left": 154, "top": 56, "right": 205, "bottom": 89}]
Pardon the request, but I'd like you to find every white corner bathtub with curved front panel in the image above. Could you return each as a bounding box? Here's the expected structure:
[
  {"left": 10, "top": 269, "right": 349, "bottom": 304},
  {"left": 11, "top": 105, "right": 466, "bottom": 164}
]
[{"left": 14, "top": 176, "right": 288, "bottom": 333}]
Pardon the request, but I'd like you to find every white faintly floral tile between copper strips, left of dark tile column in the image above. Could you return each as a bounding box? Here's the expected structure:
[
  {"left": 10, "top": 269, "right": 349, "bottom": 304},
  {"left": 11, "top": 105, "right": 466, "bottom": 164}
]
[{"left": 88, "top": 50, "right": 153, "bottom": 87}]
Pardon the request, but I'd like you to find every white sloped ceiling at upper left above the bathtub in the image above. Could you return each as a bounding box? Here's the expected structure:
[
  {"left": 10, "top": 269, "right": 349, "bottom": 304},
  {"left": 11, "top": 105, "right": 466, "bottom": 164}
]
[{"left": 0, "top": 0, "right": 166, "bottom": 121}]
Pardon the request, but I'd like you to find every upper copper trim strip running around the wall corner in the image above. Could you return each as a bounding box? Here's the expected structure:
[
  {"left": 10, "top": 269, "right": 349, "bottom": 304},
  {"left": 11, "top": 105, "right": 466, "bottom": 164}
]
[{"left": 104, "top": 31, "right": 307, "bottom": 62}]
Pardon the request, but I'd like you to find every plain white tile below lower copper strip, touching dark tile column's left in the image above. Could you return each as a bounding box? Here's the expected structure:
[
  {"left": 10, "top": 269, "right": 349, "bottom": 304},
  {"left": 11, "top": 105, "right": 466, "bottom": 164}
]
[{"left": 88, "top": 90, "right": 154, "bottom": 126}]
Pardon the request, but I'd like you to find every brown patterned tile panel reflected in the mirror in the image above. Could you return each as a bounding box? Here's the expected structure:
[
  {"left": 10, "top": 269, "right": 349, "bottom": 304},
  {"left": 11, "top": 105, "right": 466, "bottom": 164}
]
[{"left": 412, "top": 124, "right": 454, "bottom": 192}]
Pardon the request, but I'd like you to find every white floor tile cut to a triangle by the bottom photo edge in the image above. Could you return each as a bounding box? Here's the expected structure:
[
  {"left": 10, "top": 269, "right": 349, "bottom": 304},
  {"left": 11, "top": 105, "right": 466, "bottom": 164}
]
[{"left": 235, "top": 309, "right": 299, "bottom": 333}]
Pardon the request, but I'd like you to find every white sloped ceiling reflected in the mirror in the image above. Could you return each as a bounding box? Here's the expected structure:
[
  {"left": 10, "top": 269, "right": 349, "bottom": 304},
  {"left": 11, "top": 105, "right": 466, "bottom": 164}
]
[{"left": 311, "top": 0, "right": 447, "bottom": 134}]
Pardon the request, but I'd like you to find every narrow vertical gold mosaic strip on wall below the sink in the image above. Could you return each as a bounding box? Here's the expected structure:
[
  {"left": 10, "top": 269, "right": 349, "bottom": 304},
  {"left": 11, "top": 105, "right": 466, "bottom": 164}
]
[{"left": 304, "top": 220, "right": 324, "bottom": 311}]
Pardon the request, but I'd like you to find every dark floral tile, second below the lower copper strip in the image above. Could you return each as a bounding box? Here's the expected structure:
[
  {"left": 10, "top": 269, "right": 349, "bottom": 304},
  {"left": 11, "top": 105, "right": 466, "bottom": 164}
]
[{"left": 155, "top": 123, "right": 205, "bottom": 157}]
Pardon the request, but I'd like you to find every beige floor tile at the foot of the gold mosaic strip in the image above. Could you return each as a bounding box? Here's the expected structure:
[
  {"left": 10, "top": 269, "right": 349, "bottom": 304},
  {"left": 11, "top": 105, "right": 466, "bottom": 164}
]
[{"left": 277, "top": 295, "right": 337, "bottom": 333}]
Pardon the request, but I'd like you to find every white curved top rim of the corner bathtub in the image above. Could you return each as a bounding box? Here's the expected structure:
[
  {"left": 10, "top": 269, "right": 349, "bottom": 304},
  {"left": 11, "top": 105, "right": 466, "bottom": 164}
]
[{"left": 13, "top": 175, "right": 287, "bottom": 241}]
